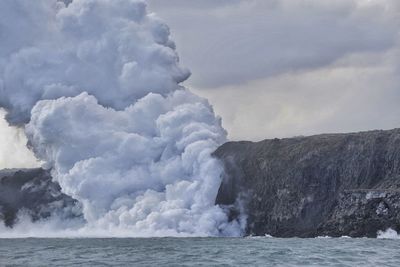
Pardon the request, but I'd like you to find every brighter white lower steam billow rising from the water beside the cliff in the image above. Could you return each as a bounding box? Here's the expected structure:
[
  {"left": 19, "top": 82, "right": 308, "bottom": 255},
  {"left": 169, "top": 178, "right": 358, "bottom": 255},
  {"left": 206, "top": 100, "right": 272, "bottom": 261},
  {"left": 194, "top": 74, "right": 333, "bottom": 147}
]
[{"left": 26, "top": 91, "right": 241, "bottom": 235}]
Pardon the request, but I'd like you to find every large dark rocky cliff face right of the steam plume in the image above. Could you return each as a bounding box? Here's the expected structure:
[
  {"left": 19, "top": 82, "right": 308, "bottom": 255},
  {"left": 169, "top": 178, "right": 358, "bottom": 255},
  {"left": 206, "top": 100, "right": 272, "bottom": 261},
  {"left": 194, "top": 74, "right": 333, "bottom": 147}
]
[{"left": 214, "top": 129, "right": 400, "bottom": 237}]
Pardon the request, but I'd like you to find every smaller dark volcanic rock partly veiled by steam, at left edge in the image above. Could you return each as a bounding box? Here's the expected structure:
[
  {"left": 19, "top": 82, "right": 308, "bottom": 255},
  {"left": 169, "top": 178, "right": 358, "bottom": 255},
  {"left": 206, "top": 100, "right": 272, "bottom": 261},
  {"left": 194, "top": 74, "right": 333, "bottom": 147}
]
[{"left": 0, "top": 169, "right": 81, "bottom": 227}]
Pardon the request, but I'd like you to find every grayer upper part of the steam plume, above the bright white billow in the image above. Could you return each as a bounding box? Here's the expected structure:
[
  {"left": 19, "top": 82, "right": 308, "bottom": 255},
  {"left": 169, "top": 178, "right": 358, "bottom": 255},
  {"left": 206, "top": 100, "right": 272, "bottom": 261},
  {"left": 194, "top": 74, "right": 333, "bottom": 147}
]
[{"left": 0, "top": 0, "right": 189, "bottom": 124}]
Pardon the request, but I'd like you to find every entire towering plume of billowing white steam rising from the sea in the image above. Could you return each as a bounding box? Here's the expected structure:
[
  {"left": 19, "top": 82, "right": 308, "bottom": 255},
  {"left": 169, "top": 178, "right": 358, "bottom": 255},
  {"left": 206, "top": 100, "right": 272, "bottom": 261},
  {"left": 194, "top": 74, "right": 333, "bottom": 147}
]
[{"left": 0, "top": 0, "right": 241, "bottom": 239}]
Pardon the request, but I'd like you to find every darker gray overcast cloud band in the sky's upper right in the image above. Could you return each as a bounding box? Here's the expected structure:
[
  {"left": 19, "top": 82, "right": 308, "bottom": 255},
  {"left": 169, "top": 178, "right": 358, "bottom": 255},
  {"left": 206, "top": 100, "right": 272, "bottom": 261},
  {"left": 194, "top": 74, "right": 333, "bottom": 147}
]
[{"left": 149, "top": 0, "right": 400, "bottom": 88}]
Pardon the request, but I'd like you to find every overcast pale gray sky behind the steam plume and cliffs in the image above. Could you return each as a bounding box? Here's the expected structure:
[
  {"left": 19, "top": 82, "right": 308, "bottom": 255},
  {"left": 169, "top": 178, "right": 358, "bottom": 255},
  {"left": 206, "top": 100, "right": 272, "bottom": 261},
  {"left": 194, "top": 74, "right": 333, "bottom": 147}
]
[{"left": 0, "top": 0, "right": 400, "bottom": 168}]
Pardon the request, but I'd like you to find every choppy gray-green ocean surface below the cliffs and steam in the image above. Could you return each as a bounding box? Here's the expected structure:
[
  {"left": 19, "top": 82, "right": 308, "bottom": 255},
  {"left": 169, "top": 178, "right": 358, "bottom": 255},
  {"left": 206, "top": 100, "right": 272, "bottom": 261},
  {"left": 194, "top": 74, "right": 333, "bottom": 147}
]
[{"left": 0, "top": 238, "right": 400, "bottom": 267}]
